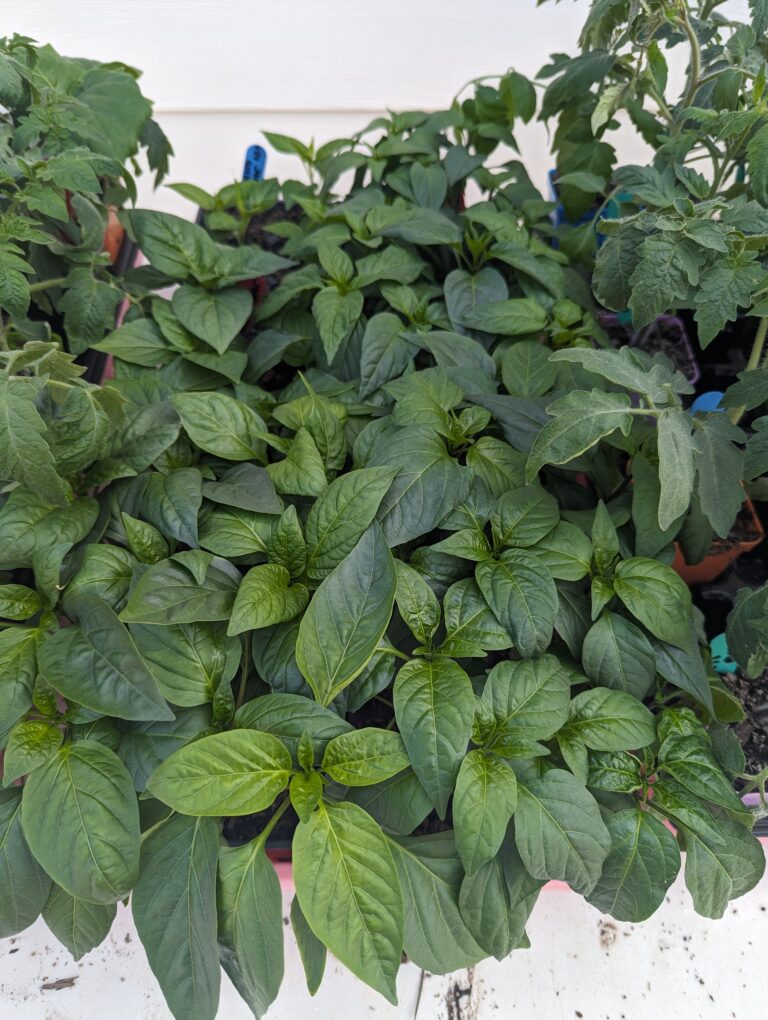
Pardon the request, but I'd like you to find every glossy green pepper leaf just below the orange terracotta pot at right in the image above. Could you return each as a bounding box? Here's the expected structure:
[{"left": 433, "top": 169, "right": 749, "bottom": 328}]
[{"left": 613, "top": 556, "right": 690, "bottom": 650}]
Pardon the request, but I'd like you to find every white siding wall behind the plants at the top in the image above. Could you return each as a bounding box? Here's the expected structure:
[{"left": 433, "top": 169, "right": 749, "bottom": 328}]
[{"left": 0, "top": 0, "right": 747, "bottom": 215}]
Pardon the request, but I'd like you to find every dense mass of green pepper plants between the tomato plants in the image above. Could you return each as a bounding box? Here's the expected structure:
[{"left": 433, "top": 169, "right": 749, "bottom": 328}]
[{"left": 0, "top": 59, "right": 765, "bottom": 1020}]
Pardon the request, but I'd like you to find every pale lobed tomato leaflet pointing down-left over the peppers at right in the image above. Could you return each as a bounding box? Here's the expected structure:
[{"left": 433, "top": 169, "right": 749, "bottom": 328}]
[{"left": 526, "top": 390, "right": 632, "bottom": 481}]
